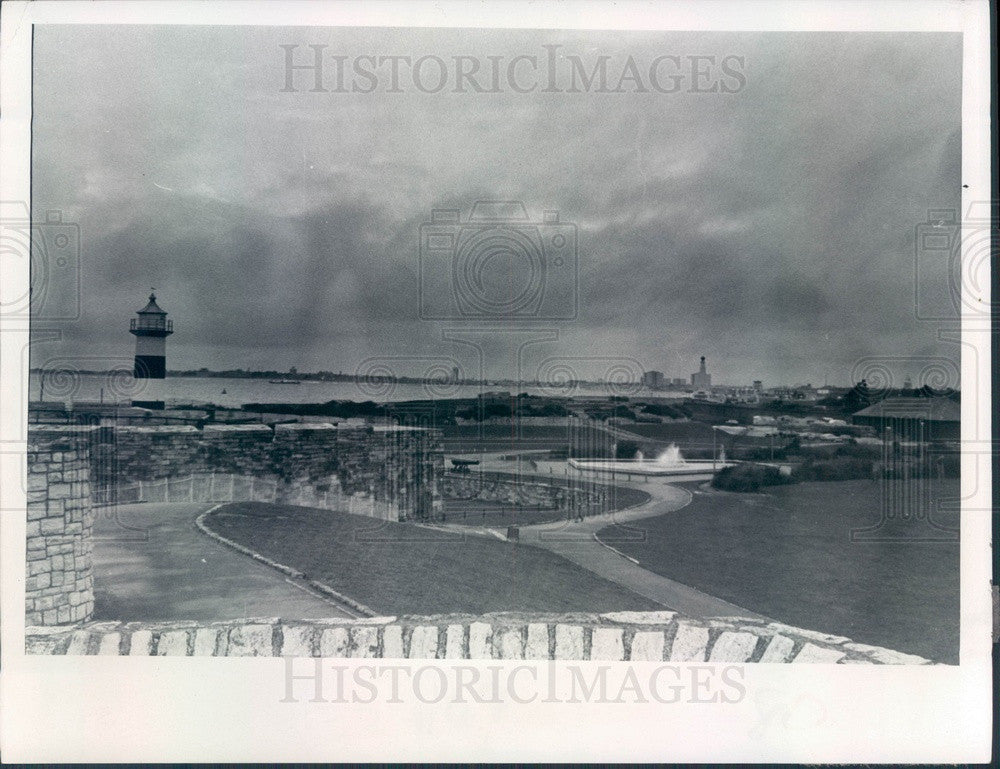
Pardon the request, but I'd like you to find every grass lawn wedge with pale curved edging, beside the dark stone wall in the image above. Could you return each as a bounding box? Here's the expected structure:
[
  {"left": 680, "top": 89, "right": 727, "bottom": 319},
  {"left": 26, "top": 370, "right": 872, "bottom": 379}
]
[{"left": 205, "top": 502, "right": 663, "bottom": 614}]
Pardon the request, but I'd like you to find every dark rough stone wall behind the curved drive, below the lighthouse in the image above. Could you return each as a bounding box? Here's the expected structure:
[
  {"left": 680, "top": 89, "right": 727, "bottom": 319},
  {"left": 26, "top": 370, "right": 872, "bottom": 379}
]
[{"left": 92, "top": 422, "right": 443, "bottom": 519}]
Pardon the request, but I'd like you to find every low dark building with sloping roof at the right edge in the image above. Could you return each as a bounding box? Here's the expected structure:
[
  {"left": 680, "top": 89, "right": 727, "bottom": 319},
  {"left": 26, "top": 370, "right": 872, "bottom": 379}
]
[{"left": 851, "top": 398, "right": 962, "bottom": 441}]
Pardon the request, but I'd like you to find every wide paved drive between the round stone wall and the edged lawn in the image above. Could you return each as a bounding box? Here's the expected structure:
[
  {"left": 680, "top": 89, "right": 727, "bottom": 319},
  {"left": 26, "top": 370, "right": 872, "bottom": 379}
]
[{"left": 94, "top": 503, "right": 351, "bottom": 622}]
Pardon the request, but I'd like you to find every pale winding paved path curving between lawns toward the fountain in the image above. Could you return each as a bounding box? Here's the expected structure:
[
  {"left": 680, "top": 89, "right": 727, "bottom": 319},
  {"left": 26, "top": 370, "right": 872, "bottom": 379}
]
[{"left": 446, "top": 452, "right": 763, "bottom": 619}]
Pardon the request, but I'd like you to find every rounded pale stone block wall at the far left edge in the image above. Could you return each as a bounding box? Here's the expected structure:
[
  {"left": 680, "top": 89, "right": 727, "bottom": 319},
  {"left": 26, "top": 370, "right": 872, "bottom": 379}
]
[{"left": 25, "top": 427, "right": 94, "bottom": 625}]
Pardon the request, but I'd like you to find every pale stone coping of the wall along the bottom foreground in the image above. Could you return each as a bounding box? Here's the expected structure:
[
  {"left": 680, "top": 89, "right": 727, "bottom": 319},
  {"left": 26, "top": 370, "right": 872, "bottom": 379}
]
[{"left": 26, "top": 611, "right": 929, "bottom": 665}]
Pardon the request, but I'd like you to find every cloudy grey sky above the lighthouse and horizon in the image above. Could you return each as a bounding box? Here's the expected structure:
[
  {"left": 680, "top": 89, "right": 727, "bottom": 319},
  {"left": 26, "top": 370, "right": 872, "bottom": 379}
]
[{"left": 32, "top": 26, "right": 961, "bottom": 385}]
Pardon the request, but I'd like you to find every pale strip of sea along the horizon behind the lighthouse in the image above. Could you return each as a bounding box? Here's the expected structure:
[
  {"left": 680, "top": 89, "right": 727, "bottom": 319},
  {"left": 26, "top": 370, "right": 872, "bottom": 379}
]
[{"left": 29, "top": 371, "right": 656, "bottom": 408}]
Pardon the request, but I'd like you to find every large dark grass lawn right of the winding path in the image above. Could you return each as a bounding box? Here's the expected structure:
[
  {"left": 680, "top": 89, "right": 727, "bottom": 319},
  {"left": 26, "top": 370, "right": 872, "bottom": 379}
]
[{"left": 598, "top": 480, "right": 959, "bottom": 663}]
